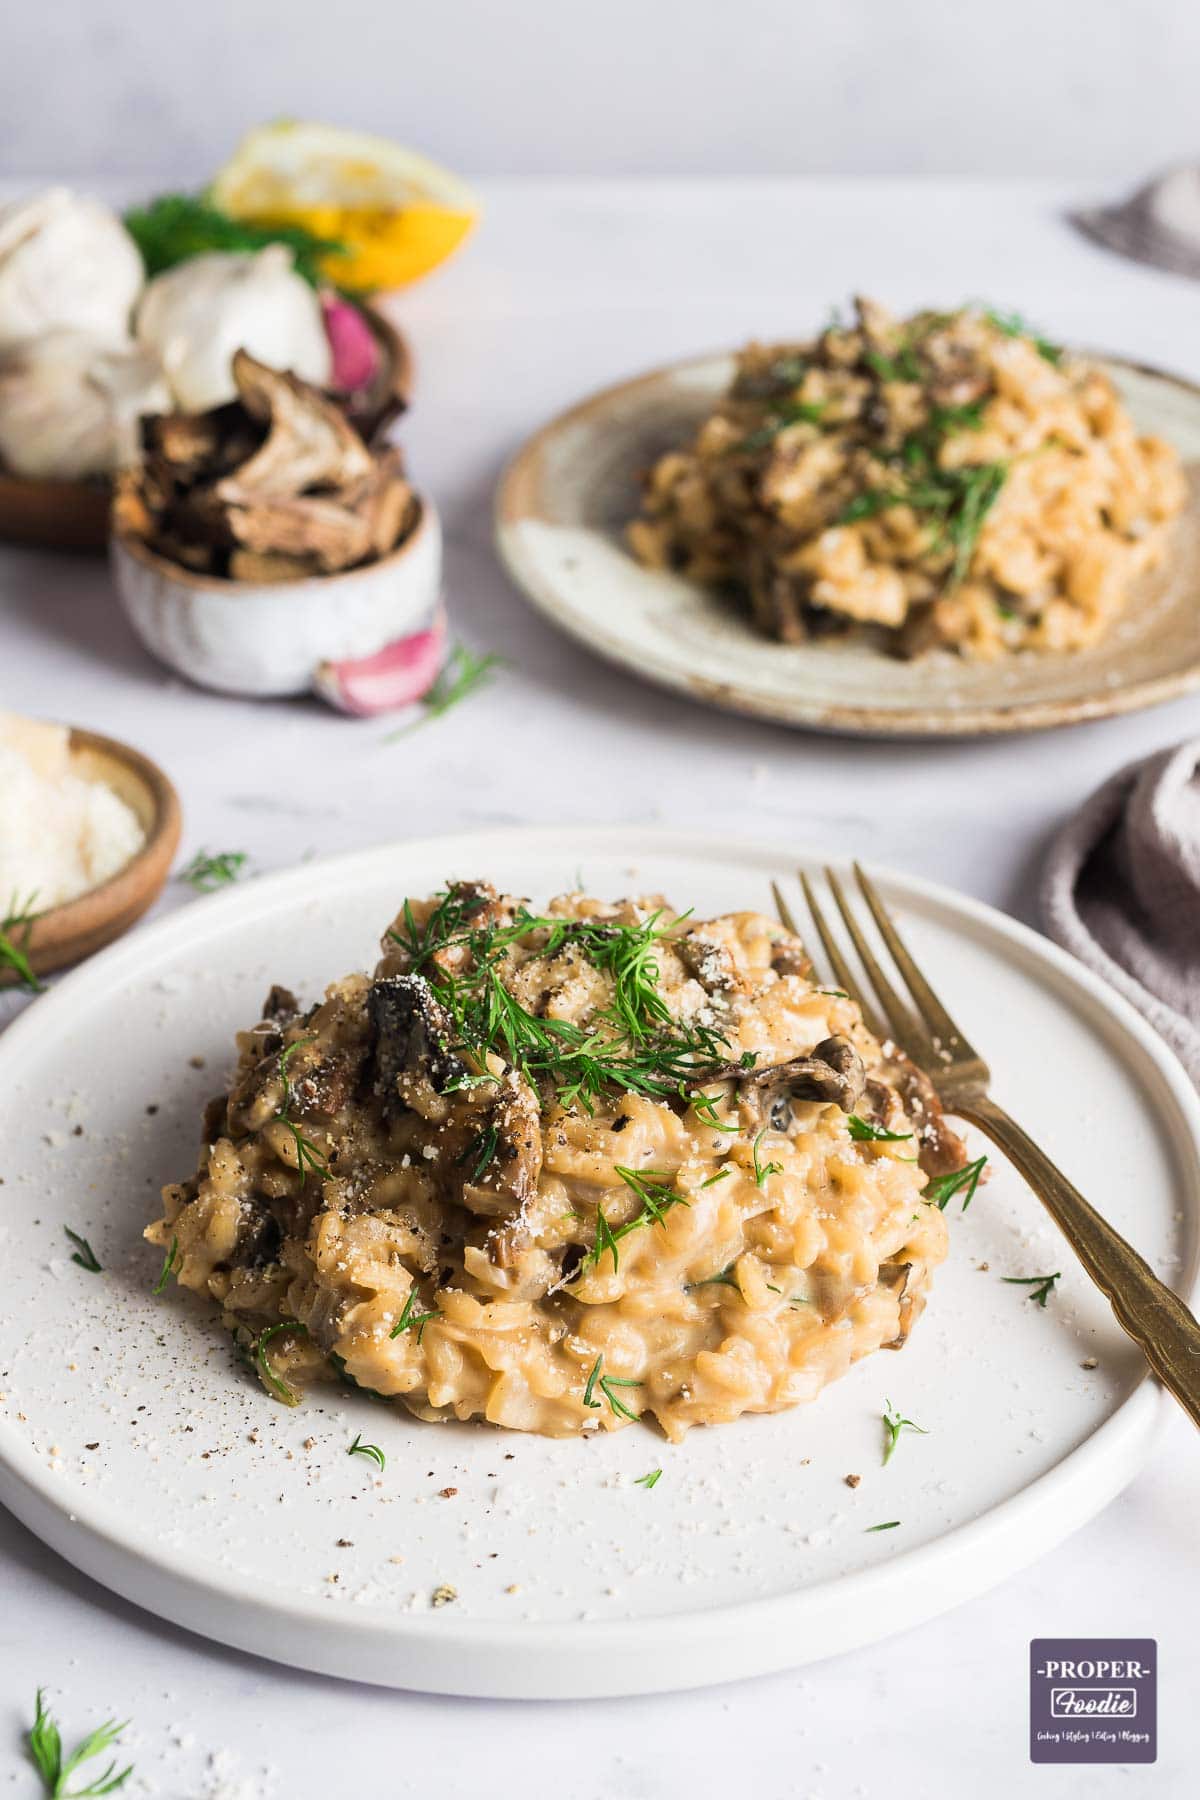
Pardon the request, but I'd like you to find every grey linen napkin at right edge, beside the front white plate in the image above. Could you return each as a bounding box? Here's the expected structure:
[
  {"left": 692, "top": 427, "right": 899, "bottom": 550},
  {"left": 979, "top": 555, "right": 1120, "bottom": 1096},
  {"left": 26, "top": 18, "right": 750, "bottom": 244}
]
[{"left": 1040, "top": 738, "right": 1200, "bottom": 1087}]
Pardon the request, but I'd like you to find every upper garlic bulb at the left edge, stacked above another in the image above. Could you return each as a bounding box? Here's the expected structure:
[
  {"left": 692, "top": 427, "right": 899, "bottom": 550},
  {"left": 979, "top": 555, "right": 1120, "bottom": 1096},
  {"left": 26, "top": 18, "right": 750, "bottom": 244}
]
[{"left": 0, "top": 187, "right": 144, "bottom": 349}]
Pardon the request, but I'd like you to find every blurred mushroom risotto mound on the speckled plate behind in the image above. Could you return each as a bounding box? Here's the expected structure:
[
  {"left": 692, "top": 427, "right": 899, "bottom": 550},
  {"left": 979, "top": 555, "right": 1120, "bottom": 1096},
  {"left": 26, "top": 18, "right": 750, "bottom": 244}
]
[{"left": 628, "top": 299, "right": 1186, "bottom": 657}]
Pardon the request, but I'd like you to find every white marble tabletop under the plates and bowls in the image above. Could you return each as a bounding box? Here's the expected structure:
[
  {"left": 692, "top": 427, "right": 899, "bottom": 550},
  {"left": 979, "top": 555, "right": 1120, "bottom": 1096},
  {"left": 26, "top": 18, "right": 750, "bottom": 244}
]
[{"left": 0, "top": 180, "right": 1200, "bottom": 1800}]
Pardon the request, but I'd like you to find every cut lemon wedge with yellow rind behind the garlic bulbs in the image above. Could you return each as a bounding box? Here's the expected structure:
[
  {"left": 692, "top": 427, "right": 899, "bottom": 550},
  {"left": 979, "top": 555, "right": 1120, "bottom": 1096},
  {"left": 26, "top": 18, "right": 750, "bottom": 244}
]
[{"left": 212, "top": 119, "right": 479, "bottom": 293}]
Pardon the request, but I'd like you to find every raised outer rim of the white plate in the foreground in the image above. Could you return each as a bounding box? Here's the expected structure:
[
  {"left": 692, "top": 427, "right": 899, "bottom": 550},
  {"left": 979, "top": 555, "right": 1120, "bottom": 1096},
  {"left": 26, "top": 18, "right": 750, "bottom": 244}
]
[{"left": 0, "top": 824, "right": 1200, "bottom": 1699}]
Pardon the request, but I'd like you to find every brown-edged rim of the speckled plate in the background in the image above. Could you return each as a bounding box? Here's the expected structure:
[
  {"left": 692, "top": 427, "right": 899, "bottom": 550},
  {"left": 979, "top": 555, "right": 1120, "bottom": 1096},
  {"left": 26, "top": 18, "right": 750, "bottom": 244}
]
[{"left": 493, "top": 347, "right": 1200, "bottom": 742}]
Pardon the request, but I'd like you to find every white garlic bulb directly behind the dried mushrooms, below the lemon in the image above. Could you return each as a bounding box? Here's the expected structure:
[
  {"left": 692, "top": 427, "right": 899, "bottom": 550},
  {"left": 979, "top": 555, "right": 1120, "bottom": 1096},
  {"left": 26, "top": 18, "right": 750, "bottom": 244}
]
[{"left": 135, "top": 243, "right": 333, "bottom": 412}]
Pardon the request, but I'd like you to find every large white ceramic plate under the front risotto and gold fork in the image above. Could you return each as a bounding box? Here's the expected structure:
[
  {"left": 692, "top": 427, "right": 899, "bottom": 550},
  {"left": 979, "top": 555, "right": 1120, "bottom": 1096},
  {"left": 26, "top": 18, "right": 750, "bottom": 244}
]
[{"left": 0, "top": 828, "right": 1200, "bottom": 1697}]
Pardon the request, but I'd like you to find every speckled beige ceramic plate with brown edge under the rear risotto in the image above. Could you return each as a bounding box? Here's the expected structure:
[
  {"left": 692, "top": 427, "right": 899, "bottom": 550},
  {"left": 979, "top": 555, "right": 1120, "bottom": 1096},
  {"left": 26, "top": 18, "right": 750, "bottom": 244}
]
[{"left": 497, "top": 356, "right": 1200, "bottom": 738}]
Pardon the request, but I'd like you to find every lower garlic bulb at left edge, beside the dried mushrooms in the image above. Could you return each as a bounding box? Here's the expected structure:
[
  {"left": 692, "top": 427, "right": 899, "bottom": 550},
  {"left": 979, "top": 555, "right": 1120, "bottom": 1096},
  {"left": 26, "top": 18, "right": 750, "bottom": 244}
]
[{"left": 0, "top": 331, "right": 171, "bottom": 481}]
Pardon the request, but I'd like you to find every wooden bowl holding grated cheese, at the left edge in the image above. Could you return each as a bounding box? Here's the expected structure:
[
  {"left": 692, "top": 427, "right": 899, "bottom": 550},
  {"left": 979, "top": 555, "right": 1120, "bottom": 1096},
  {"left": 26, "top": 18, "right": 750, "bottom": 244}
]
[{"left": 0, "top": 729, "right": 180, "bottom": 986}]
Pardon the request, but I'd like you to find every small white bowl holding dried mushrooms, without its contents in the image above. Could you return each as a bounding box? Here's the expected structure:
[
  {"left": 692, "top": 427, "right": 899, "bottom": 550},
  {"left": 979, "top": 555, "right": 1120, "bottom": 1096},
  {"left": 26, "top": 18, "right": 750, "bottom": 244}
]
[{"left": 110, "top": 499, "right": 443, "bottom": 697}]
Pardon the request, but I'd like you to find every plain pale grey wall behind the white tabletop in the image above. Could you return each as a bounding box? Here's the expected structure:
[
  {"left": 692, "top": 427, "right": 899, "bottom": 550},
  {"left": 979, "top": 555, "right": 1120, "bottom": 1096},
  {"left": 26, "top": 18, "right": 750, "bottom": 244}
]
[{"left": 0, "top": 0, "right": 1200, "bottom": 185}]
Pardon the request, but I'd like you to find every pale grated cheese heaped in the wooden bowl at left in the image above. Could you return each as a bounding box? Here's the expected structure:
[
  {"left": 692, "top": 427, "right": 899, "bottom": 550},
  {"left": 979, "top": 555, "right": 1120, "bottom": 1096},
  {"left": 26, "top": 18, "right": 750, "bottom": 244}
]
[{"left": 0, "top": 713, "right": 146, "bottom": 913}]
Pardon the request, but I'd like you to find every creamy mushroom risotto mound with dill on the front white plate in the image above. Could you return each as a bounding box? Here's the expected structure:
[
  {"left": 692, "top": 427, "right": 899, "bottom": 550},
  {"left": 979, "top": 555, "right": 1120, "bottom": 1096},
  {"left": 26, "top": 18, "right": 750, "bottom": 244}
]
[{"left": 146, "top": 884, "right": 964, "bottom": 1438}]
